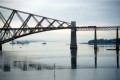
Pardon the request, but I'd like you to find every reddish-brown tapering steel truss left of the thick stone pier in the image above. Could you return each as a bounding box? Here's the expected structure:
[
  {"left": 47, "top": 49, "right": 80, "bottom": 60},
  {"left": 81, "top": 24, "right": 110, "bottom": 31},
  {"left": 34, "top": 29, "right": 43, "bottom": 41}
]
[{"left": 0, "top": 6, "right": 70, "bottom": 44}]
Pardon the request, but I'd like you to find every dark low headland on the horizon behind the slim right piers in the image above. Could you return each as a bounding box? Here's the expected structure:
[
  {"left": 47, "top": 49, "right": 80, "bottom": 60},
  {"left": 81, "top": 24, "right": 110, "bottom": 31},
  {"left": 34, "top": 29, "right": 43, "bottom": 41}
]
[{"left": 83, "top": 38, "right": 120, "bottom": 45}]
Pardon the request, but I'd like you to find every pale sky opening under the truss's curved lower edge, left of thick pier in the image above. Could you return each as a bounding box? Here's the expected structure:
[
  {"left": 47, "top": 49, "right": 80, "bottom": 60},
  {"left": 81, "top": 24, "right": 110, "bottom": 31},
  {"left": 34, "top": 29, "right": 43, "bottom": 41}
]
[{"left": 3, "top": 29, "right": 70, "bottom": 50}]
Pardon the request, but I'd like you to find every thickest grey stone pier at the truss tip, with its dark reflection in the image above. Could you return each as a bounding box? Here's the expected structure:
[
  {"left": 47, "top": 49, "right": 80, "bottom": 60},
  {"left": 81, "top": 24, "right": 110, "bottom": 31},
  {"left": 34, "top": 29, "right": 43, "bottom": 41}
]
[{"left": 70, "top": 21, "right": 77, "bottom": 69}]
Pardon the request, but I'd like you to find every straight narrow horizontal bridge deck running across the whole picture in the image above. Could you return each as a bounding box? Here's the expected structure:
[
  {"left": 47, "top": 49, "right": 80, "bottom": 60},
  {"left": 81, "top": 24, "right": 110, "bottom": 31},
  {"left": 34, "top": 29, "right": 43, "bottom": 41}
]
[{"left": 0, "top": 26, "right": 120, "bottom": 31}]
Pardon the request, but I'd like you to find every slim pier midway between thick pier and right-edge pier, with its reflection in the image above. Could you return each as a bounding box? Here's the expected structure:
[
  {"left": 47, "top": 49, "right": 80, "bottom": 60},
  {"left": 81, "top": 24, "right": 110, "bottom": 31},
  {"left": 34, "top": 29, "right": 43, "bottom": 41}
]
[{"left": 94, "top": 26, "right": 97, "bottom": 68}]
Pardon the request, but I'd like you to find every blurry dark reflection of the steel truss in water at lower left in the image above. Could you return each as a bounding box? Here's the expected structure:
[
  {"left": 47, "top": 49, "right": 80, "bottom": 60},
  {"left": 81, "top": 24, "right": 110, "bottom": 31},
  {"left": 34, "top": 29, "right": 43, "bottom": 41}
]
[{"left": 0, "top": 52, "right": 62, "bottom": 71}]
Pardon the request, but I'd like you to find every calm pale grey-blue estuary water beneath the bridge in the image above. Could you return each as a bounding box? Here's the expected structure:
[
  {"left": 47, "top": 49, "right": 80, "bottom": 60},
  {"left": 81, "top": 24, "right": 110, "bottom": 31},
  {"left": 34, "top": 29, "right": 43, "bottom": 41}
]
[{"left": 0, "top": 42, "right": 120, "bottom": 80}]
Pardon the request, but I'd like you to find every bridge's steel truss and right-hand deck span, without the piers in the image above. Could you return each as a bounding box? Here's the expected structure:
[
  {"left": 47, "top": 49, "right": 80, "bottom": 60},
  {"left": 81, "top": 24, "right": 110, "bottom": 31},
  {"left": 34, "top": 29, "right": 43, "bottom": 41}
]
[{"left": 0, "top": 6, "right": 120, "bottom": 44}]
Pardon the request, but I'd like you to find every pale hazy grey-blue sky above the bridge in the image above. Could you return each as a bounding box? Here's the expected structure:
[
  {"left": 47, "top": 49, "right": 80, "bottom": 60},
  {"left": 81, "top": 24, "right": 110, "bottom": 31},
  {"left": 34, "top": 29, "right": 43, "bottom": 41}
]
[{"left": 0, "top": 0, "right": 120, "bottom": 42}]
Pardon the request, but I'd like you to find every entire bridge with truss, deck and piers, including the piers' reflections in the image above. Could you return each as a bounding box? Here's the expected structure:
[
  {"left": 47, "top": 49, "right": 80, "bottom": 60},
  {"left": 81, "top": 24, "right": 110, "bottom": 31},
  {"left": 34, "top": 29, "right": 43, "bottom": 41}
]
[{"left": 0, "top": 6, "right": 120, "bottom": 69}]
